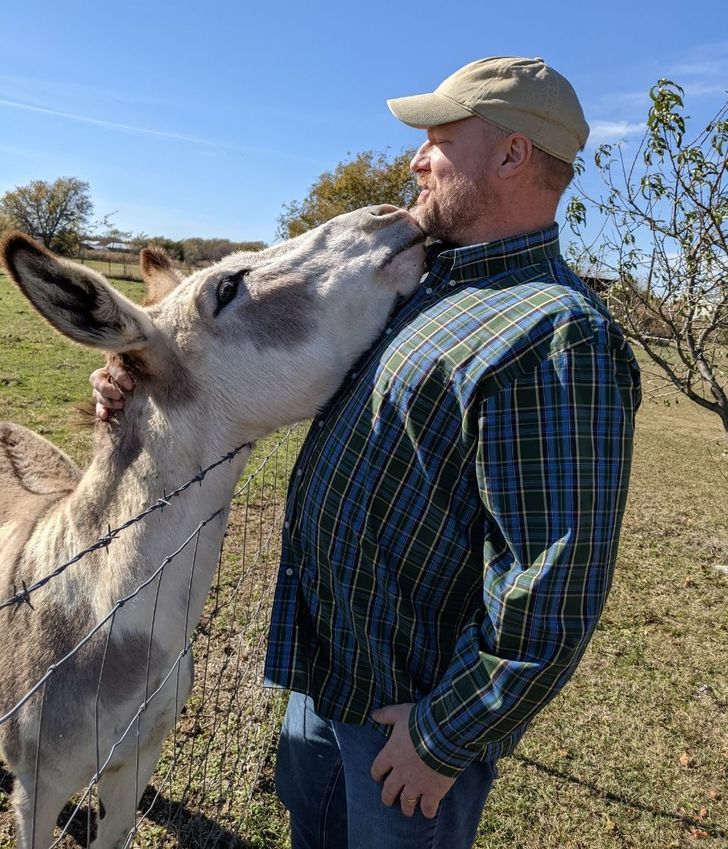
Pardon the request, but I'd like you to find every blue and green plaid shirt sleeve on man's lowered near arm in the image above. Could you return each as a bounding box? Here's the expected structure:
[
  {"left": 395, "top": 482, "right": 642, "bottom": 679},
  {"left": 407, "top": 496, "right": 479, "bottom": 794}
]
[{"left": 410, "top": 343, "right": 639, "bottom": 776}]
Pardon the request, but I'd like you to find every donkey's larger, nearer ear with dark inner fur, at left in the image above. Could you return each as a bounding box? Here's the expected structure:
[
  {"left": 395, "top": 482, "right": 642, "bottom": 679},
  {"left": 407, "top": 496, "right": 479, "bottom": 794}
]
[{"left": 0, "top": 232, "right": 154, "bottom": 353}]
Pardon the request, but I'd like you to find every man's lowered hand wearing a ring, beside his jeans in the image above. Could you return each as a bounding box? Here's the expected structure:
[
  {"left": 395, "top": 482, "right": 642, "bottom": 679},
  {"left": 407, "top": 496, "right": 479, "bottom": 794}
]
[{"left": 371, "top": 703, "right": 455, "bottom": 819}]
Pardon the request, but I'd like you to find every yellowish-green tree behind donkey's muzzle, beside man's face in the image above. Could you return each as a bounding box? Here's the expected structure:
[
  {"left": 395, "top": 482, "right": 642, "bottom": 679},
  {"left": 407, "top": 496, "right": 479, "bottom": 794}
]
[{"left": 276, "top": 150, "right": 417, "bottom": 239}]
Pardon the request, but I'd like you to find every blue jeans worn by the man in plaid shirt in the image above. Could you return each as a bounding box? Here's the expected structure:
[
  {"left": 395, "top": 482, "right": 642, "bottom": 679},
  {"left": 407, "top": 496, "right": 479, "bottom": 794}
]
[{"left": 276, "top": 693, "right": 497, "bottom": 849}]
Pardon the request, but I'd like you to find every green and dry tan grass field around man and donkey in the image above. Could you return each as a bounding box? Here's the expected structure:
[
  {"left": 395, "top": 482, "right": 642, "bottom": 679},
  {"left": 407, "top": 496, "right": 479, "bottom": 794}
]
[{"left": 0, "top": 264, "right": 728, "bottom": 849}]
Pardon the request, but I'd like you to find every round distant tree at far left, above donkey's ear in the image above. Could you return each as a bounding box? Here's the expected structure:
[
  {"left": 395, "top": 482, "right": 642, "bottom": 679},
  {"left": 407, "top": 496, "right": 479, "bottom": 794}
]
[{"left": 0, "top": 177, "right": 93, "bottom": 252}]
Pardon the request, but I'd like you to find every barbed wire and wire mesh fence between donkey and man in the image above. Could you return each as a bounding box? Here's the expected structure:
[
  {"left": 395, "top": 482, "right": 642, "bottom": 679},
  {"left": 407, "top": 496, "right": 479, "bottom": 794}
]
[{"left": 0, "top": 425, "right": 300, "bottom": 846}]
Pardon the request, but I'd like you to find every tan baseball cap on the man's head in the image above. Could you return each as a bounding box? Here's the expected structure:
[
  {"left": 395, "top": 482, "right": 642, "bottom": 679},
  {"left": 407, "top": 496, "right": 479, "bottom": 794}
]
[{"left": 387, "top": 56, "right": 589, "bottom": 162}]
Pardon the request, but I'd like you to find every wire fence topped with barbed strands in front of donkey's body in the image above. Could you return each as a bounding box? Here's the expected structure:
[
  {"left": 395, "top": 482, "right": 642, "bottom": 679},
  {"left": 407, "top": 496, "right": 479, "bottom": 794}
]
[{"left": 0, "top": 425, "right": 305, "bottom": 849}]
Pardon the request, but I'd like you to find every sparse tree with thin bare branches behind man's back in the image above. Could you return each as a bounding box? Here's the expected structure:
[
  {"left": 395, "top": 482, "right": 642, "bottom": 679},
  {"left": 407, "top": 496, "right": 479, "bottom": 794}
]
[{"left": 567, "top": 79, "right": 728, "bottom": 433}]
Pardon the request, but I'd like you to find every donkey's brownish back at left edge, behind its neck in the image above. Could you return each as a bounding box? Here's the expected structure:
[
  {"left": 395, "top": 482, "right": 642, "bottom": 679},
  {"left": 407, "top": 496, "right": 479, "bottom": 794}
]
[{"left": 0, "top": 422, "right": 81, "bottom": 521}]
